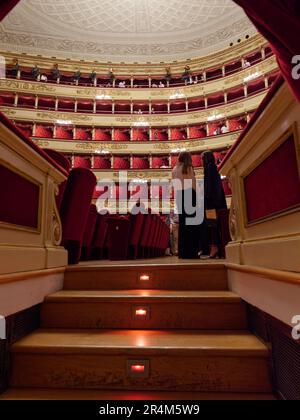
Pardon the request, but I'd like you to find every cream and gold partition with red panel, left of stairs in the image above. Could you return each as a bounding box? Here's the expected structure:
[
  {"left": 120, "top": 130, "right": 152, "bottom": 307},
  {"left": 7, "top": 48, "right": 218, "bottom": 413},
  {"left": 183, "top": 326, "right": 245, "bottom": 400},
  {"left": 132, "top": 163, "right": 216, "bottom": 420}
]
[{"left": 0, "top": 113, "right": 67, "bottom": 274}]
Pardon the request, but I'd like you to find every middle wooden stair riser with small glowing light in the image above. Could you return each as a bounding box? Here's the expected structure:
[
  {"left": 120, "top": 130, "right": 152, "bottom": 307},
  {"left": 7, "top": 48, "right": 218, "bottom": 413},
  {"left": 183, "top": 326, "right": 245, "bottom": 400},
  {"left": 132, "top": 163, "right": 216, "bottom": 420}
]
[{"left": 41, "top": 303, "right": 247, "bottom": 330}]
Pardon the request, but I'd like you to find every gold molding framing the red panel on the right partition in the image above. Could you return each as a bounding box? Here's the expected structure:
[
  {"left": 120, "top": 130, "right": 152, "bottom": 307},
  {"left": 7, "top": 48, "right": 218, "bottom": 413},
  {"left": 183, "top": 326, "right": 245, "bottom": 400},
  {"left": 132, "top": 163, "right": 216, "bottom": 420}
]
[{"left": 240, "top": 122, "right": 300, "bottom": 228}]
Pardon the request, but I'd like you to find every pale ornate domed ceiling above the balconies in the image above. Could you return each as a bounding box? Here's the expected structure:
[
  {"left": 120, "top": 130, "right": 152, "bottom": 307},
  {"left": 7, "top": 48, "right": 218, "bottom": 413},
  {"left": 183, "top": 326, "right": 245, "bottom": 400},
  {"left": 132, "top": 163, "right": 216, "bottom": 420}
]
[{"left": 0, "top": 0, "right": 255, "bottom": 62}]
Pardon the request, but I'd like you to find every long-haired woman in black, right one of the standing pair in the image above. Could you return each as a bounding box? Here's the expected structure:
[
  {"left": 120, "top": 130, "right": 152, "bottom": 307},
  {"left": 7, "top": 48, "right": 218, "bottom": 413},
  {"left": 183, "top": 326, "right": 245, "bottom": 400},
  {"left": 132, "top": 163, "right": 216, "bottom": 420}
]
[{"left": 202, "top": 151, "right": 227, "bottom": 259}]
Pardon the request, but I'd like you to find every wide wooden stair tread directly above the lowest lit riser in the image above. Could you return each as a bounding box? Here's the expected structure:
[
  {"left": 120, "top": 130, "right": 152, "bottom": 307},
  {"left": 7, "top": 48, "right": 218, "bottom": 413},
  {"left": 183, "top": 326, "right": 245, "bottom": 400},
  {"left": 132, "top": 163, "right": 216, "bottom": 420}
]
[{"left": 12, "top": 330, "right": 269, "bottom": 357}]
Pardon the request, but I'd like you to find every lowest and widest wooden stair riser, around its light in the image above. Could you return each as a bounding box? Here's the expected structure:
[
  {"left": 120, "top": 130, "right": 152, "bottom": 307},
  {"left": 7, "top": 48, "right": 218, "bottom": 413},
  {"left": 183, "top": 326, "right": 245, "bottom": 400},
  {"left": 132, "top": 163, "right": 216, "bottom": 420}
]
[{"left": 11, "top": 354, "right": 271, "bottom": 393}]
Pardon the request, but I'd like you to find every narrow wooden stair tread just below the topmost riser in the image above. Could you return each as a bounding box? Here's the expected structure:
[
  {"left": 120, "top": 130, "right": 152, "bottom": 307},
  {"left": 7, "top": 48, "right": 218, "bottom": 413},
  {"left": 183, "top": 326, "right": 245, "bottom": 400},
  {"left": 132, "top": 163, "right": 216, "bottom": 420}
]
[{"left": 45, "top": 290, "right": 241, "bottom": 303}]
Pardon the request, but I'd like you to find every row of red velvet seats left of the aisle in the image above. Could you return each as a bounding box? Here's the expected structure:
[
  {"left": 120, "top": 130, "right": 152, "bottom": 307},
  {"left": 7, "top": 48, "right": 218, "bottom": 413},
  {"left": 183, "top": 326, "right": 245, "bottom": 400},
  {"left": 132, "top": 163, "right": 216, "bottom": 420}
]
[{"left": 45, "top": 149, "right": 169, "bottom": 264}]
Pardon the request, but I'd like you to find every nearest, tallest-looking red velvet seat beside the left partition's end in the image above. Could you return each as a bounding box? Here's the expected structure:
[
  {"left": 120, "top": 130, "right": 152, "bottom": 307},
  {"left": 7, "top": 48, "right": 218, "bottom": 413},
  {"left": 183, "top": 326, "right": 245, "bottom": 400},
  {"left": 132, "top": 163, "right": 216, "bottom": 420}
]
[{"left": 61, "top": 168, "right": 97, "bottom": 264}]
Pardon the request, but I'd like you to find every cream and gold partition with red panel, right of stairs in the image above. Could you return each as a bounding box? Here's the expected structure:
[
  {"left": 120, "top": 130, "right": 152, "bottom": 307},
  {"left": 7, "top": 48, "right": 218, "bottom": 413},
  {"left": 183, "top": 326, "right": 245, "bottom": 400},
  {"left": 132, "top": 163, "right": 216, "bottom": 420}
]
[{"left": 221, "top": 78, "right": 300, "bottom": 272}]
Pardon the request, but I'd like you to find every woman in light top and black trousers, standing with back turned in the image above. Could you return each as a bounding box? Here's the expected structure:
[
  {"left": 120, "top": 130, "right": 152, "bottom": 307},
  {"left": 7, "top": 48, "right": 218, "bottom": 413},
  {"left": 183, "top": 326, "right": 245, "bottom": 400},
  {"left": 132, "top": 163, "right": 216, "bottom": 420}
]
[{"left": 172, "top": 152, "right": 200, "bottom": 259}]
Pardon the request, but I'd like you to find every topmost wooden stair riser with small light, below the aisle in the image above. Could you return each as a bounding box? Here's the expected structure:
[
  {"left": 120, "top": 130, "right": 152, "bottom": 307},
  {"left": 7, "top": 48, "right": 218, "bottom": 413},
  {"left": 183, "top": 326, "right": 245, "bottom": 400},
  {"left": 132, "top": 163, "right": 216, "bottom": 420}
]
[{"left": 64, "top": 267, "right": 228, "bottom": 291}]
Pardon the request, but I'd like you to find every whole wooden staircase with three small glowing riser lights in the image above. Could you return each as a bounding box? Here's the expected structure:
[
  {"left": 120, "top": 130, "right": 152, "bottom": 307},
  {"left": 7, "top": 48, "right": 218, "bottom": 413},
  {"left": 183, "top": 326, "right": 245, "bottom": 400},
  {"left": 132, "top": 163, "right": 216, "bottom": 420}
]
[{"left": 4, "top": 264, "right": 272, "bottom": 400}]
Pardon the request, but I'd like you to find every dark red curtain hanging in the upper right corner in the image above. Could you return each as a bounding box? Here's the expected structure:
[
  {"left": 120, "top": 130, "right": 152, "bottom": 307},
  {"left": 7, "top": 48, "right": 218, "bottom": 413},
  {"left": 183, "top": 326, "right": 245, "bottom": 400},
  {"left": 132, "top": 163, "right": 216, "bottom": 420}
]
[{"left": 234, "top": 0, "right": 300, "bottom": 101}]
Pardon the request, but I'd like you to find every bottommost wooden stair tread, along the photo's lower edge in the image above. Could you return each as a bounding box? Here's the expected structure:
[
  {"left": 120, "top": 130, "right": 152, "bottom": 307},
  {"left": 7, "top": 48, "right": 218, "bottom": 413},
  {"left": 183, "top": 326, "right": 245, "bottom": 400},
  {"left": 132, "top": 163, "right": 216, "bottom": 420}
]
[{"left": 0, "top": 388, "right": 276, "bottom": 401}]
